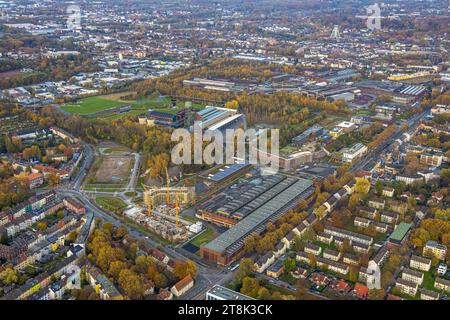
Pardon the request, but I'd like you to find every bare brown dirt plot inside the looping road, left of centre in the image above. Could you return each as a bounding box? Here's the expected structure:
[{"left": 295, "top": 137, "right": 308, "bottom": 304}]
[{"left": 95, "top": 155, "right": 133, "bottom": 183}]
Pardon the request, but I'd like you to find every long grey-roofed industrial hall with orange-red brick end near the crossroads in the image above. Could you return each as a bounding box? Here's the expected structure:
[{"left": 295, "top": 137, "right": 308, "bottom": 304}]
[{"left": 200, "top": 175, "right": 314, "bottom": 265}]
